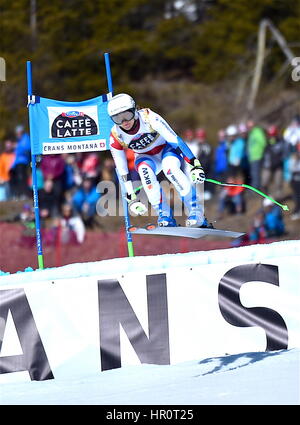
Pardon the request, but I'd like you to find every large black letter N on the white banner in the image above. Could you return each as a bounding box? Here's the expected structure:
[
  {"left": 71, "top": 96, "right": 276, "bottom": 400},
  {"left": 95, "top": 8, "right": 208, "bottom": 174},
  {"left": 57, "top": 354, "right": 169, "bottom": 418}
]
[{"left": 98, "top": 274, "right": 170, "bottom": 370}]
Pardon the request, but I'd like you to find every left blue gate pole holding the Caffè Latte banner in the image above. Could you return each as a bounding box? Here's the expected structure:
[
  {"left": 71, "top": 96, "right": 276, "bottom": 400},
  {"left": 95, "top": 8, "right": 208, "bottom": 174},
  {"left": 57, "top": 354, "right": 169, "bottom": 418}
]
[{"left": 27, "top": 61, "right": 44, "bottom": 269}]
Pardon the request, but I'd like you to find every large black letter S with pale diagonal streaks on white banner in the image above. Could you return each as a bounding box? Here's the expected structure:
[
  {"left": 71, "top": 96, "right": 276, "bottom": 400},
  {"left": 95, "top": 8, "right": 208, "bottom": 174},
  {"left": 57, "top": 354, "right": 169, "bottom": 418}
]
[{"left": 219, "top": 264, "right": 288, "bottom": 351}]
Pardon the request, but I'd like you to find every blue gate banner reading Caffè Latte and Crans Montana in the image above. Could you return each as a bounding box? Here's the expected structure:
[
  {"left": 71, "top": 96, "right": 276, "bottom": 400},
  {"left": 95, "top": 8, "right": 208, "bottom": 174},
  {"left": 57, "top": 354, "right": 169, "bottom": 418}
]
[{"left": 28, "top": 95, "right": 113, "bottom": 155}]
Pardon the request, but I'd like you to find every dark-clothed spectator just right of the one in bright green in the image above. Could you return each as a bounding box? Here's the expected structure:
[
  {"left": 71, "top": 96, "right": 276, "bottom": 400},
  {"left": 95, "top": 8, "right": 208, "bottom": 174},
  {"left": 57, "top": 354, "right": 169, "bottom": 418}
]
[{"left": 262, "top": 125, "right": 286, "bottom": 198}]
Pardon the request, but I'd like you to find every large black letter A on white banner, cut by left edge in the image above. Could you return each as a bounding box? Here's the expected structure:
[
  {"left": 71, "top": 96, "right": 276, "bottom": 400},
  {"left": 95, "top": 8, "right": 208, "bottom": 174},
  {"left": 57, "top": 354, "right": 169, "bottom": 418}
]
[{"left": 0, "top": 289, "right": 54, "bottom": 381}]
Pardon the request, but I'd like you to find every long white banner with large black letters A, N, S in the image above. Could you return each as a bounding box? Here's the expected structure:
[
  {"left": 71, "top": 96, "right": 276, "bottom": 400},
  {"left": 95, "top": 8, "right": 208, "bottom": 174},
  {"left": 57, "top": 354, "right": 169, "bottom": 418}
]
[{"left": 0, "top": 257, "right": 300, "bottom": 383}]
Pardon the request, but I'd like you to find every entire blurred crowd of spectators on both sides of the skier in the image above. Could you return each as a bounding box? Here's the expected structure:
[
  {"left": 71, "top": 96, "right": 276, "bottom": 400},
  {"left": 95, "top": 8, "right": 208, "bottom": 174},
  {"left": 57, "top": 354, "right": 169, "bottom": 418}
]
[{"left": 0, "top": 115, "right": 300, "bottom": 247}]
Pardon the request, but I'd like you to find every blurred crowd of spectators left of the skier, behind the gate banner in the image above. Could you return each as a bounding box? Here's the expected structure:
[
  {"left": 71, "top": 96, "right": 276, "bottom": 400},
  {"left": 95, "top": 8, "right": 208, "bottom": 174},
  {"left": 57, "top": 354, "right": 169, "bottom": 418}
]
[{"left": 0, "top": 126, "right": 116, "bottom": 243}]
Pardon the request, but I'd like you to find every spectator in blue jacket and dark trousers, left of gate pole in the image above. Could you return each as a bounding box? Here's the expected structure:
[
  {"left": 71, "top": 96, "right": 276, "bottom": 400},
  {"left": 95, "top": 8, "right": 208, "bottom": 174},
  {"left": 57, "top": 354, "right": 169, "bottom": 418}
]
[{"left": 11, "top": 125, "right": 31, "bottom": 199}]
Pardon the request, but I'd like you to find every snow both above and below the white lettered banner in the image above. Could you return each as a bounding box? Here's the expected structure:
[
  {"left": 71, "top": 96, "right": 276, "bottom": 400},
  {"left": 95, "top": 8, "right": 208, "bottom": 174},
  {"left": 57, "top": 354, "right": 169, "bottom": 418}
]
[{"left": 0, "top": 241, "right": 300, "bottom": 405}]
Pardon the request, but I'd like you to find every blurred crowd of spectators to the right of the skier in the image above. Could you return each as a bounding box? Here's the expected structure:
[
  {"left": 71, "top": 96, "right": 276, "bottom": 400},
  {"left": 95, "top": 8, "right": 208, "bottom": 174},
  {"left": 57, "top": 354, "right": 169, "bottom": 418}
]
[{"left": 184, "top": 115, "right": 300, "bottom": 243}]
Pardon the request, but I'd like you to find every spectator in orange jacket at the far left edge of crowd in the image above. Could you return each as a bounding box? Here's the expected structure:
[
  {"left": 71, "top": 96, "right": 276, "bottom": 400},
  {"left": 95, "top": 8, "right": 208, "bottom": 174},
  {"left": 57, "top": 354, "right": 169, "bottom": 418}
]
[{"left": 0, "top": 139, "right": 15, "bottom": 201}]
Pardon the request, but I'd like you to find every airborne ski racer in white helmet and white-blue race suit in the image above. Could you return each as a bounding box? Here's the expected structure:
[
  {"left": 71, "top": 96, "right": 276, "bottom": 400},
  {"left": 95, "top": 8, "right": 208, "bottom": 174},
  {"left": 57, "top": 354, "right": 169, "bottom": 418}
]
[{"left": 108, "top": 94, "right": 213, "bottom": 228}]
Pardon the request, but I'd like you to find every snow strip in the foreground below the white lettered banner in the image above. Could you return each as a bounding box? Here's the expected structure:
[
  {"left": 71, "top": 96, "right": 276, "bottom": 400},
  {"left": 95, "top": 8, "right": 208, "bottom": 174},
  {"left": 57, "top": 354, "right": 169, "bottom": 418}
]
[{"left": 0, "top": 348, "right": 300, "bottom": 405}]
